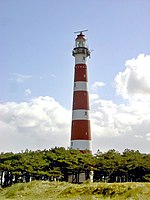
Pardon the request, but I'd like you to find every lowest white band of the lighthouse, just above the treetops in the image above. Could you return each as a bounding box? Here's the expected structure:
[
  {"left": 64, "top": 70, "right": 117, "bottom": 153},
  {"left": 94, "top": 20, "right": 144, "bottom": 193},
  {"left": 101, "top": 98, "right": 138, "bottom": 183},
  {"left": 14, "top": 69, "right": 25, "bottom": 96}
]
[{"left": 71, "top": 140, "right": 92, "bottom": 151}]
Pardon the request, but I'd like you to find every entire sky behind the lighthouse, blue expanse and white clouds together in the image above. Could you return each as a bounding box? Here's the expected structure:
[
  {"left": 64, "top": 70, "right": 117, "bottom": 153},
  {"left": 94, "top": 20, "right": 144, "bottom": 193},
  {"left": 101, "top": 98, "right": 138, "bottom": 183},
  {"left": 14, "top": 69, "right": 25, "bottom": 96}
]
[{"left": 0, "top": 0, "right": 150, "bottom": 153}]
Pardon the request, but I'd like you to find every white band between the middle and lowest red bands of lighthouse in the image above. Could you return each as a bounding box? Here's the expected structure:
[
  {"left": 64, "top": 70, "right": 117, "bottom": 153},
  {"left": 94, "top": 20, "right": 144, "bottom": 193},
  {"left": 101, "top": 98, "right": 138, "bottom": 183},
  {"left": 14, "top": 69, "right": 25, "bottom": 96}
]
[{"left": 72, "top": 110, "right": 89, "bottom": 120}]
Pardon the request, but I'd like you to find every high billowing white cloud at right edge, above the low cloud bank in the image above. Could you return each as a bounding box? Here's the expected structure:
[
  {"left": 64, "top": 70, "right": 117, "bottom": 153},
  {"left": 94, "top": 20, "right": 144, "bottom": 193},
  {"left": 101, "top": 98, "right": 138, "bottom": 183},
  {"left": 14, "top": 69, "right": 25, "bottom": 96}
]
[{"left": 115, "top": 54, "right": 150, "bottom": 99}]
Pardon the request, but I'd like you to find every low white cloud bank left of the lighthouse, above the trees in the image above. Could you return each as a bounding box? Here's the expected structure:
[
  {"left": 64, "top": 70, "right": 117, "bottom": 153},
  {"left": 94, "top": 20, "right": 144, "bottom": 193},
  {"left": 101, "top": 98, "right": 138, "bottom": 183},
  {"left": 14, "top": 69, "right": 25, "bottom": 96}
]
[{"left": 0, "top": 96, "right": 71, "bottom": 151}]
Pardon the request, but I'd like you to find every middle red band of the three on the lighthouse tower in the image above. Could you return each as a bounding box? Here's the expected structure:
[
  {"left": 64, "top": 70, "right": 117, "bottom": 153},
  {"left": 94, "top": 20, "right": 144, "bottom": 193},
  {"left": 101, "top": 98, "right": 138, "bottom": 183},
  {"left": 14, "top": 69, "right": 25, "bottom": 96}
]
[{"left": 73, "top": 91, "right": 89, "bottom": 110}]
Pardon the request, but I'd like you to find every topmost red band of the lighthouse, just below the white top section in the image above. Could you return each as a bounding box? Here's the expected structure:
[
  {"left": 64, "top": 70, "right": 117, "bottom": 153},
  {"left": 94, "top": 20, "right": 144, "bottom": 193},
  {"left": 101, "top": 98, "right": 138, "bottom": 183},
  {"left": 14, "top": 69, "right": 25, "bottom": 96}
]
[{"left": 74, "top": 64, "right": 88, "bottom": 82}]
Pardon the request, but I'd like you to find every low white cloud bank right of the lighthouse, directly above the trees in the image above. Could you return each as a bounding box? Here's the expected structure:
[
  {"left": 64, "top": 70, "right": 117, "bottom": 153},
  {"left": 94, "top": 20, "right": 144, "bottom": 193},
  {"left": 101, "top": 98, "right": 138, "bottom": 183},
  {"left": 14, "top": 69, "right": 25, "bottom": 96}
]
[{"left": 91, "top": 96, "right": 150, "bottom": 152}]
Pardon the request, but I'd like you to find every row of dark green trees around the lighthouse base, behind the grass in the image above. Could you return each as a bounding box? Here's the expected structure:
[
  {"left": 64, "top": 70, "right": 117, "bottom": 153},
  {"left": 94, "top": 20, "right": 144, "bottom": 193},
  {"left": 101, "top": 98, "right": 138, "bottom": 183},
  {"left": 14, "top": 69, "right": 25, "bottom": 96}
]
[{"left": 0, "top": 147, "right": 150, "bottom": 187}]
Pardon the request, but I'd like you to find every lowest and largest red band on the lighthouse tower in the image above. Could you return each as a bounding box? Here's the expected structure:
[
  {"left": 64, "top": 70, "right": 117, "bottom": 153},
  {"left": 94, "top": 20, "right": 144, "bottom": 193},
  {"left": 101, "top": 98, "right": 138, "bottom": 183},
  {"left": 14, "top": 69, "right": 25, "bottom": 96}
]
[{"left": 71, "top": 120, "right": 91, "bottom": 140}]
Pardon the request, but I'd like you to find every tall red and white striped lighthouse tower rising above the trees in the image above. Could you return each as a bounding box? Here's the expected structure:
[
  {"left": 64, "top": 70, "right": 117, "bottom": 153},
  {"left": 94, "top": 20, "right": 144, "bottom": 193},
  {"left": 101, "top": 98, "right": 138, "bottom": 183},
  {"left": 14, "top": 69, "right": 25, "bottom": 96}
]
[{"left": 71, "top": 31, "right": 92, "bottom": 152}]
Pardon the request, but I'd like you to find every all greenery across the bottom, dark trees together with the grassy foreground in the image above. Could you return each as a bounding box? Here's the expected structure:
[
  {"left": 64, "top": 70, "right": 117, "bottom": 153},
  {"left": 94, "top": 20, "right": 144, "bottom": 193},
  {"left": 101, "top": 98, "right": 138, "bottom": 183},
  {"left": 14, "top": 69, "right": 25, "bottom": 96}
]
[{"left": 0, "top": 147, "right": 150, "bottom": 200}]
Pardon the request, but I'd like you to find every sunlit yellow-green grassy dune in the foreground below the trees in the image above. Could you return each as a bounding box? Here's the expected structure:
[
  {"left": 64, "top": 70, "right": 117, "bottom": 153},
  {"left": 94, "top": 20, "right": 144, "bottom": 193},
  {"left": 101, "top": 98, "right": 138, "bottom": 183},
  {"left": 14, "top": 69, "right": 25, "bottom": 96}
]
[{"left": 0, "top": 181, "right": 150, "bottom": 200}]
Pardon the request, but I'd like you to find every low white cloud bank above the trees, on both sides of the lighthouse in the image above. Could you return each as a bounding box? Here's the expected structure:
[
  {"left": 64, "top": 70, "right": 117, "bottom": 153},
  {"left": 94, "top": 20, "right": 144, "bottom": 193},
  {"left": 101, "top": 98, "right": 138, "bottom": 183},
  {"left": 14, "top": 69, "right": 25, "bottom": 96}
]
[{"left": 0, "top": 96, "right": 150, "bottom": 152}]
